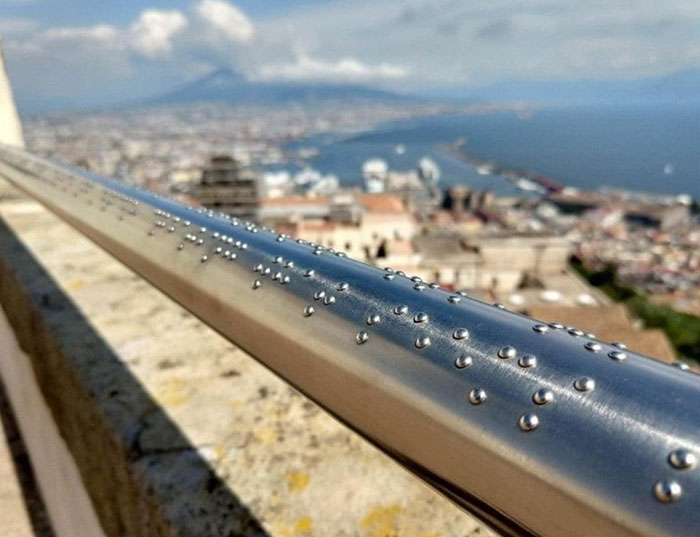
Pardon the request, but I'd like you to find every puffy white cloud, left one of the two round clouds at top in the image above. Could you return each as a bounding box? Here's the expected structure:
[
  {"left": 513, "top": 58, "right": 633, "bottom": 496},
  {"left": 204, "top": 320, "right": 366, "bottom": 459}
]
[{"left": 130, "top": 9, "right": 187, "bottom": 58}]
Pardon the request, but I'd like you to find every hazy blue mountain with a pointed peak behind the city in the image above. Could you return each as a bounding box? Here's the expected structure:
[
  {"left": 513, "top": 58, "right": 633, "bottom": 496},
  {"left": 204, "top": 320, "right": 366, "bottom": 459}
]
[{"left": 148, "top": 69, "right": 418, "bottom": 105}]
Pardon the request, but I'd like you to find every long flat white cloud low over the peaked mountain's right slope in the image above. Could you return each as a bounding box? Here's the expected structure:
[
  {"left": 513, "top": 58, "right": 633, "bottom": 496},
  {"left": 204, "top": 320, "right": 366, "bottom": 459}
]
[{"left": 260, "top": 55, "right": 408, "bottom": 82}]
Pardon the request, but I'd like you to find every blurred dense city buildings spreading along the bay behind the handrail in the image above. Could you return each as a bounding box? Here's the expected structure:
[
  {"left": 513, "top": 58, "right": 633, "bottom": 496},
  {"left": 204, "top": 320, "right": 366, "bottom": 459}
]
[{"left": 25, "top": 102, "right": 700, "bottom": 360}]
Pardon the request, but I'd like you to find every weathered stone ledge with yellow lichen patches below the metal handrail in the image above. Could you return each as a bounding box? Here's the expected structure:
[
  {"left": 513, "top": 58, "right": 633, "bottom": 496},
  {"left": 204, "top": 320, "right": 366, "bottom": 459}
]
[{"left": 0, "top": 181, "right": 491, "bottom": 537}]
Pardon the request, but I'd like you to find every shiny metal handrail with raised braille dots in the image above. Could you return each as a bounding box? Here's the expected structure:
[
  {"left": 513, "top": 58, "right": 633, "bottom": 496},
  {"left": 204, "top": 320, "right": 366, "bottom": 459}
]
[{"left": 0, "top": 142, "right": 700, "bottom": 537}]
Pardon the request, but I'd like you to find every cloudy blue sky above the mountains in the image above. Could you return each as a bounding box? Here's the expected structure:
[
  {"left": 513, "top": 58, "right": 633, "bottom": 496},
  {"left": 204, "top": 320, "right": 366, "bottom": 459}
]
[{"left": 0, "top": 0, "right": 700, "bottom": 110}]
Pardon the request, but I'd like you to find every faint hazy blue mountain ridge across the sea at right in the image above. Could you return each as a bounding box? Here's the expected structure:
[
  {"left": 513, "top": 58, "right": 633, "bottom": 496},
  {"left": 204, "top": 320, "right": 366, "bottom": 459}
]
[{"left": 433, "top": 69, "right": 700, "bottom": 105}]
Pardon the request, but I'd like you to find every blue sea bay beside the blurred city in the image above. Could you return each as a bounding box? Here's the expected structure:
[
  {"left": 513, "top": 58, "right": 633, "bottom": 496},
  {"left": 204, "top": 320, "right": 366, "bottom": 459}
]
[{"left": 284, "top": 106, "right": 700, "bottom": 200}]
